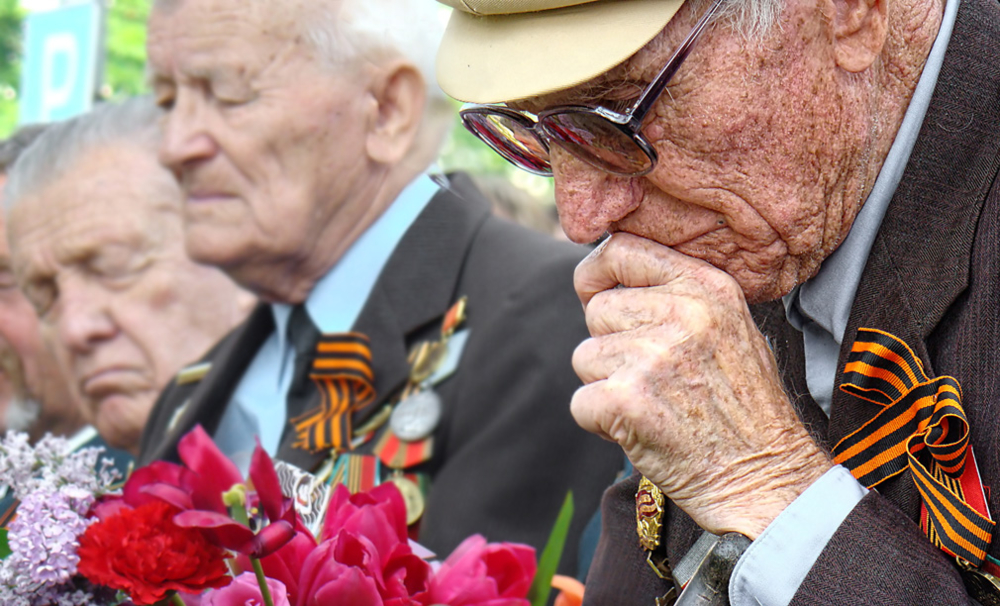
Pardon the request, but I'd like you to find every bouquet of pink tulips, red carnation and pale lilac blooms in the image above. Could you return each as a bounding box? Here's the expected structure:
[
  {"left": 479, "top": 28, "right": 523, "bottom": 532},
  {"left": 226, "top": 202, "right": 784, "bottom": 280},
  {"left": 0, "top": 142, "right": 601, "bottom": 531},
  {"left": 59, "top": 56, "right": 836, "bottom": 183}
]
[{"left": 0, "top": 427, "right": 572, "bottom": 606}]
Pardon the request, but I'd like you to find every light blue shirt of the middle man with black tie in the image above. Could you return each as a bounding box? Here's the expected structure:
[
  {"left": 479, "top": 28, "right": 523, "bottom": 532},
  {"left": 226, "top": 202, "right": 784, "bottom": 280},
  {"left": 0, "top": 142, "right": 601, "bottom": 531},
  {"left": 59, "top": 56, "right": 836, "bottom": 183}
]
[{"left": 215, "top": 175, "right": 438, "bottom": 473}]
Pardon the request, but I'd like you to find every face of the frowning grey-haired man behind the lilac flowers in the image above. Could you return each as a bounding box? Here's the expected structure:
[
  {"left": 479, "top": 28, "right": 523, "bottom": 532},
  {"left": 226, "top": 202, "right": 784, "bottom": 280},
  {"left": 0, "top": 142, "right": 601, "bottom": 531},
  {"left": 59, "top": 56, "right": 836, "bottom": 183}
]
[{"left": 9, "top": 144, "right": 250, "bottom": 450}]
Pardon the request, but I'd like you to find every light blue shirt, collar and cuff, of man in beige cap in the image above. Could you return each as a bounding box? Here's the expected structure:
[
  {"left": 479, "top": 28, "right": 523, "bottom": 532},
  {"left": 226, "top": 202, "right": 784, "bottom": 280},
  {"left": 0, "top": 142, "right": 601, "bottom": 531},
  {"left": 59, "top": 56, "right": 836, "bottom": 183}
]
[{"left": 729, "top": 0, "right": 959, "bottom": 606}]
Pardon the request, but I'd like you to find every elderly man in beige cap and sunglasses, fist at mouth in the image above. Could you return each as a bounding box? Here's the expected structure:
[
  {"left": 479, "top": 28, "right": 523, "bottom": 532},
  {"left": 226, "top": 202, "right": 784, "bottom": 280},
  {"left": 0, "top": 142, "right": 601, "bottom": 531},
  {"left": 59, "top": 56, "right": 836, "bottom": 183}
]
[{"left": 438, "top": 0, "right": 1000, "bottom": 606}]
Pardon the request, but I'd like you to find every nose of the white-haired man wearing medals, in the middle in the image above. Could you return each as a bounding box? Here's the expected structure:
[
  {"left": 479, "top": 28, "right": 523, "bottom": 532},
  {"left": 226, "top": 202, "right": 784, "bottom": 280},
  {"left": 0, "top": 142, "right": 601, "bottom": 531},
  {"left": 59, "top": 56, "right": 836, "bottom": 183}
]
[{"left": 159, "top": 89, "right": 217, "bottom": 180}]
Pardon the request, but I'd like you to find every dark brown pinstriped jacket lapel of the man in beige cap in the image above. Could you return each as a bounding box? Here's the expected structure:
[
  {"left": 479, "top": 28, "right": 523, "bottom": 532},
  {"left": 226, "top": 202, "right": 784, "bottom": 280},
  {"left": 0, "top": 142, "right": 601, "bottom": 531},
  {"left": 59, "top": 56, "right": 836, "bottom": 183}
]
[{"left": 830, "top": 0, "right": 1000, "bottom": 518}]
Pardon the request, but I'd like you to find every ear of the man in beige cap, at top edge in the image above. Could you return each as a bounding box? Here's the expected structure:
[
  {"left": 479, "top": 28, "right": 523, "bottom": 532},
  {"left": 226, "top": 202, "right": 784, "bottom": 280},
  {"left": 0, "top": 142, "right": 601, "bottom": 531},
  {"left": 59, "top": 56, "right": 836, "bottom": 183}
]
[{"left": 832, "top": 0, "right": 891, "bottom": 73}]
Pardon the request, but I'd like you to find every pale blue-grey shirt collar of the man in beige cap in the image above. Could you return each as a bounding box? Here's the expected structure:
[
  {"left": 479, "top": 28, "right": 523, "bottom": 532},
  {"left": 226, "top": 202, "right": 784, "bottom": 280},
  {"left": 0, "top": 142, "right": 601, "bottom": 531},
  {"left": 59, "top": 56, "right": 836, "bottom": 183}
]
[{"left": 782, "top": 0, "right": 960, "bottom": 344}]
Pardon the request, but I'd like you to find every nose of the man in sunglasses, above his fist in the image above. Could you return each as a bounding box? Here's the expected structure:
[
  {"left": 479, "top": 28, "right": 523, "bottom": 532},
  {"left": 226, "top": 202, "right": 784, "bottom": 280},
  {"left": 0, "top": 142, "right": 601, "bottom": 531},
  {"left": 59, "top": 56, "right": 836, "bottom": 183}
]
[{"left": 549, "top": 145, "right": 642, "bottom": 244}]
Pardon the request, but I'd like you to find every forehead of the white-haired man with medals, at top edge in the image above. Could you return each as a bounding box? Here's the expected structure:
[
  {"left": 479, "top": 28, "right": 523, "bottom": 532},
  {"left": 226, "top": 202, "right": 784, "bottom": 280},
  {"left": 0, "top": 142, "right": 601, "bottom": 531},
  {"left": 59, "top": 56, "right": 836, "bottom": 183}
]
[{"left": 148, "top": 0, "right": 303, "bottom": 77}]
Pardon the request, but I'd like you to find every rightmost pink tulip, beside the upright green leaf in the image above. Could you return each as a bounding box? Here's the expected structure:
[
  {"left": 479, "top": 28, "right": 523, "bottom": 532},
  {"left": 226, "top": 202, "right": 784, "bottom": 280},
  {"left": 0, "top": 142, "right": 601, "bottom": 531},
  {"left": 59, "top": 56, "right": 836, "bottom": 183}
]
[{"left": 424, "top": 535, "right": 537, "bottom": 606}]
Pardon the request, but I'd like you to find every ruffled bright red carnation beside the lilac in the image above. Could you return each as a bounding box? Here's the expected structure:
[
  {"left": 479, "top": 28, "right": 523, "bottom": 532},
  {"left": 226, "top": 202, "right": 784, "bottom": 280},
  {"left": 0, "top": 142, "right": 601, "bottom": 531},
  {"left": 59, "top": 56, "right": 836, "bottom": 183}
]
[{"left": 77, "top": 501, "right": 232, "bottom": 605}]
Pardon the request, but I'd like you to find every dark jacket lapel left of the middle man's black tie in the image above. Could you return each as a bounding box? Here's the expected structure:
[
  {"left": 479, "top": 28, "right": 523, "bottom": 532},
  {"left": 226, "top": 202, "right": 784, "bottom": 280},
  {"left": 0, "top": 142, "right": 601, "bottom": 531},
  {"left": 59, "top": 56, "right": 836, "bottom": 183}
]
[{"left": 142, "top": 304, "right": 274, "bottom": 461}]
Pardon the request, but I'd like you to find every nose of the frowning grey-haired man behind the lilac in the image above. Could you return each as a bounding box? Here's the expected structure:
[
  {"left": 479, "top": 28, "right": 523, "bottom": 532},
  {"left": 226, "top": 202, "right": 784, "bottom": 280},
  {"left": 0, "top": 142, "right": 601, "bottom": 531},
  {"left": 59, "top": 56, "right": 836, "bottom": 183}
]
[{"left": 53, "top": 278, "right": 118, "bottom": 354}]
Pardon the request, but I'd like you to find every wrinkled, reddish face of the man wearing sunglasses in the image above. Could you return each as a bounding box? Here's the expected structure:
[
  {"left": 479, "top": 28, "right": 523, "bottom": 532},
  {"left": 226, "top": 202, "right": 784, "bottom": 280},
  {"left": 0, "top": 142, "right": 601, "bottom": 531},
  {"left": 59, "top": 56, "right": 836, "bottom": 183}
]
[{"left": 511, "top": 2, "right": 868, "bottom": 301}]
